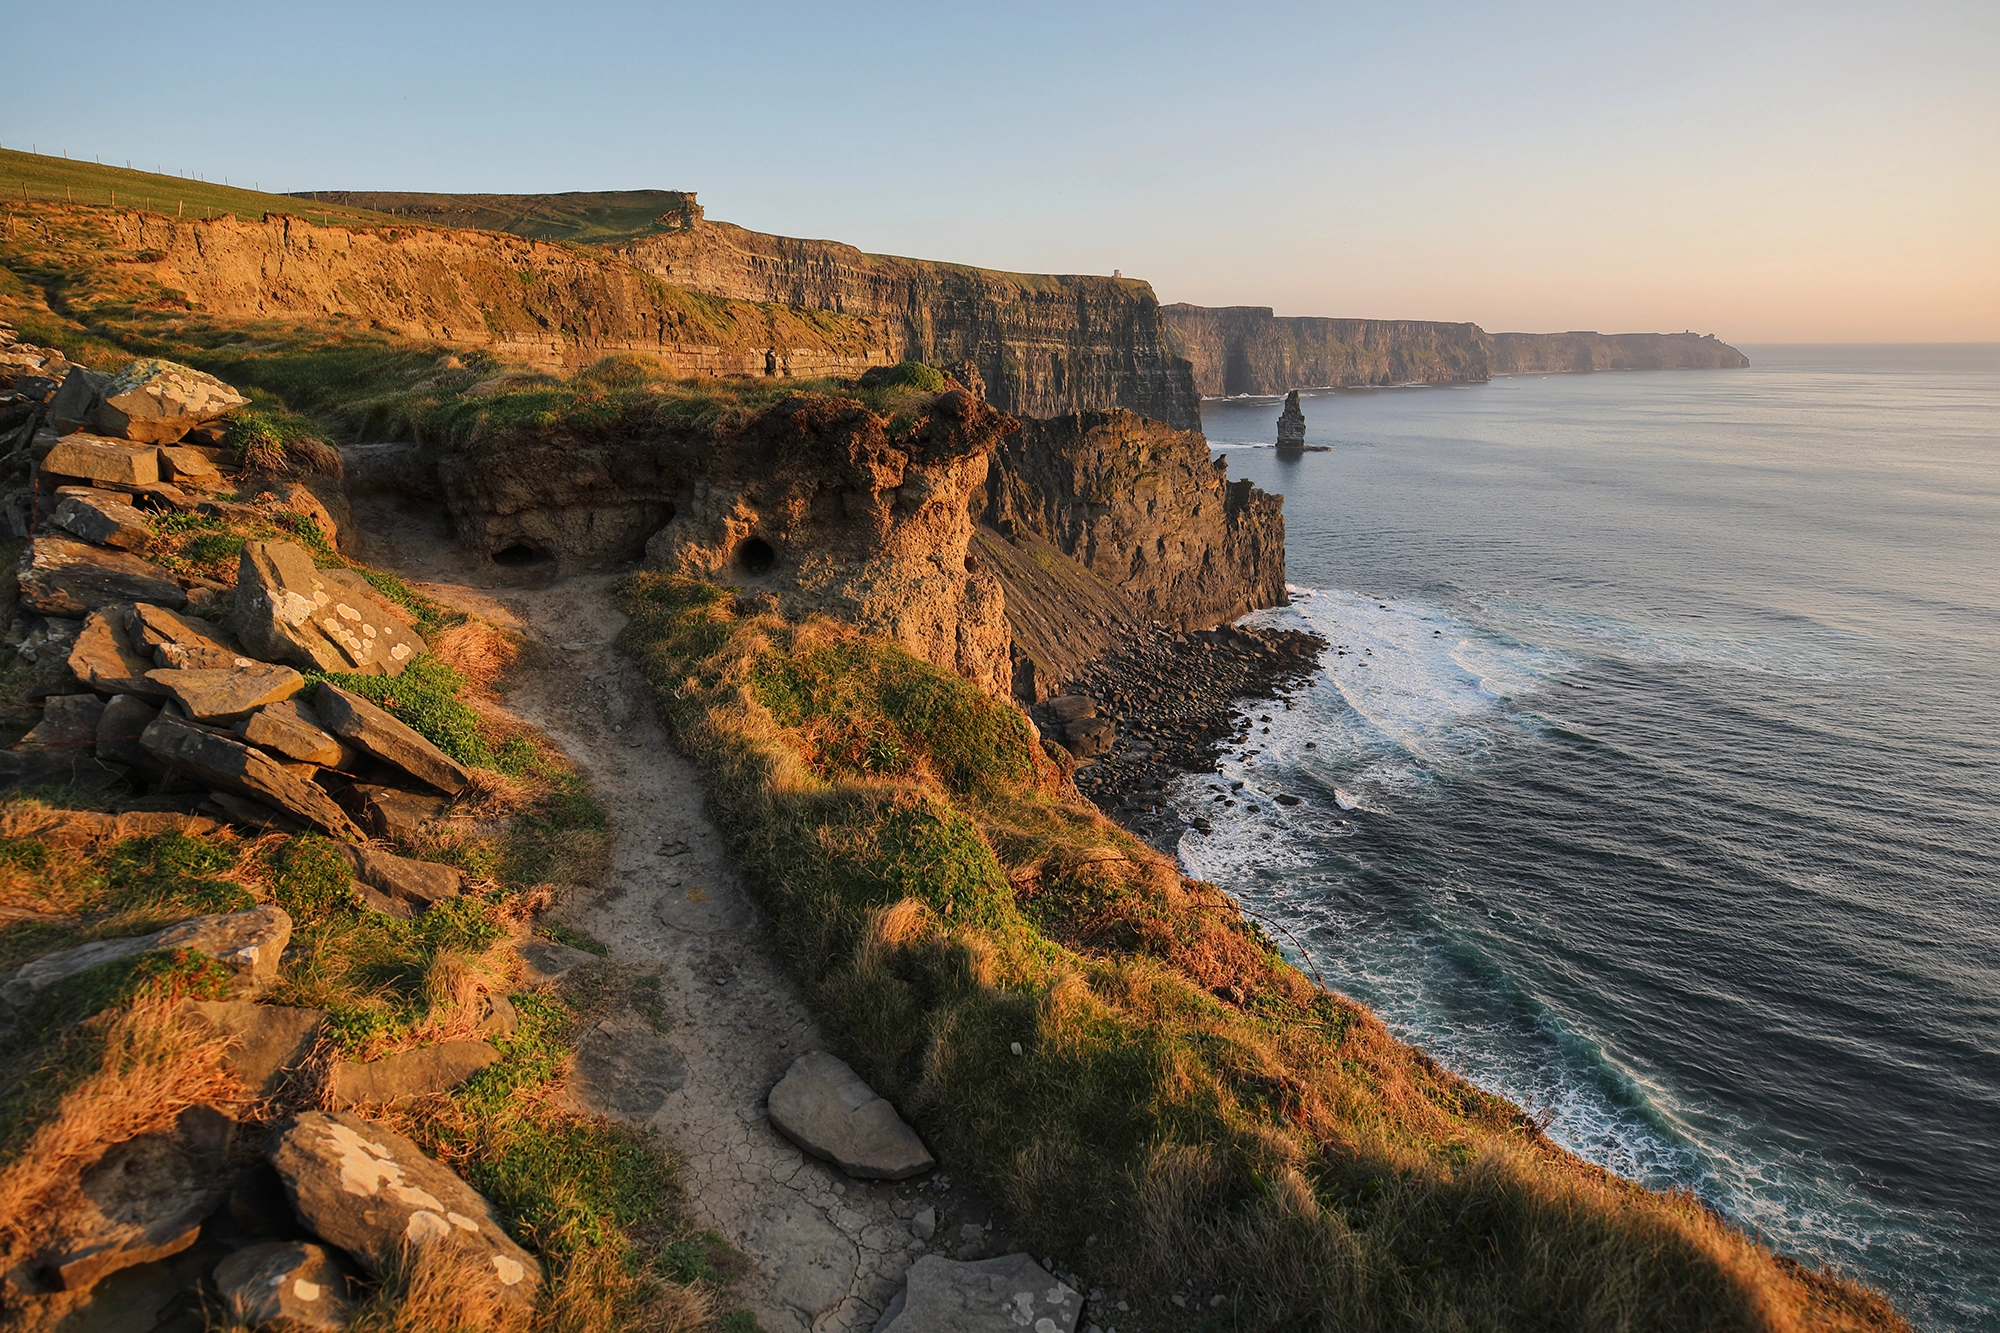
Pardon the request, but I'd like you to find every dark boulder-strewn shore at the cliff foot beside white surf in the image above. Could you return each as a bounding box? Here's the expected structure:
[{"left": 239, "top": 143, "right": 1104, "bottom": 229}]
[{"left": 1034, "top": 624, "right": 1326, "bottom": 855}]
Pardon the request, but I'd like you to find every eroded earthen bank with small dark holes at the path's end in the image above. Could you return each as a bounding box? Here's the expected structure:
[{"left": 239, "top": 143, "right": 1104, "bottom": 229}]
[{"left": 438, "top": 390, "right": 1014, "bottom": 693}]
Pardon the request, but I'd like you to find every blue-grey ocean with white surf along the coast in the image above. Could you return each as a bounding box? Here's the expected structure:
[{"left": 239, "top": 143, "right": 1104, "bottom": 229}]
[{"left": 1174, "top": 346, "right": 2000, "bottom": 1329}]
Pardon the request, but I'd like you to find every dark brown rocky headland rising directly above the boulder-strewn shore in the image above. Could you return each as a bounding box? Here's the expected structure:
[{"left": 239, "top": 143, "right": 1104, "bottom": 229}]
[{"left": 982, "top": 410, "right": 1286, "bottom": 699}]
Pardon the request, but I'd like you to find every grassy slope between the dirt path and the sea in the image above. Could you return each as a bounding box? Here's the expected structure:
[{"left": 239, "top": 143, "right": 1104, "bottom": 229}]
[{"left": 626, "top": 574, "right": 1902, "bottom": 1331}]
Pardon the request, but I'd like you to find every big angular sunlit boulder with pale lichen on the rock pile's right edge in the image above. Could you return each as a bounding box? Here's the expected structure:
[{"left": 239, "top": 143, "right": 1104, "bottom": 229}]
[{"left": 232, "top": 542, "right": 424, "bottom": 677}]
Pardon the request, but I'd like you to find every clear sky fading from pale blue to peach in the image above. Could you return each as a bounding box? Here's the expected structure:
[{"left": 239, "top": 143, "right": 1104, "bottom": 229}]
[{"left": 0, "top": 0, "right": 2000, "bottom": 344}]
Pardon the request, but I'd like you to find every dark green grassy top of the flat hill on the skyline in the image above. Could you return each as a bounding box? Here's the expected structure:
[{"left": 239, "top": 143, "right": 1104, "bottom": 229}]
[{"left": 298, "top": 190, "right": 692, "bottom": 244}]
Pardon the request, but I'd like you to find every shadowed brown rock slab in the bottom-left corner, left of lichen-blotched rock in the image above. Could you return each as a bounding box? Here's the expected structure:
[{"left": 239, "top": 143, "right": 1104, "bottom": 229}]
[{"left": 46, "top": 1107, "right": 236, "bottom": 1291}]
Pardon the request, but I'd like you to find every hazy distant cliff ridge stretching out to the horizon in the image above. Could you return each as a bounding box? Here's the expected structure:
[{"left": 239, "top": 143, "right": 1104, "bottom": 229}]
[{"left": 1160, "top": 304, "right": 1750, "bottom": 398}]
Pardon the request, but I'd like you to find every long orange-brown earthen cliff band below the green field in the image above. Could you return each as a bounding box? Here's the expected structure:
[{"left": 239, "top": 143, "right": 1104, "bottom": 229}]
[{"left": 94, "top": 210, "right": 896, "bottom": 376}]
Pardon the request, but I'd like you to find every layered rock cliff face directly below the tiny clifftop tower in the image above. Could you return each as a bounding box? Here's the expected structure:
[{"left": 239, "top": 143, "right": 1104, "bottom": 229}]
[{"left": 620, "top": 220, "right": 1200, "bottom": 428}]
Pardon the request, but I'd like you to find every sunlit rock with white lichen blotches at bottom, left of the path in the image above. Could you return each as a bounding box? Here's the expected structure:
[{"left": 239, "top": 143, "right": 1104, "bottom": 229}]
[{"left": 270, "top": 1111, "right": 542, "bottom": 1309}]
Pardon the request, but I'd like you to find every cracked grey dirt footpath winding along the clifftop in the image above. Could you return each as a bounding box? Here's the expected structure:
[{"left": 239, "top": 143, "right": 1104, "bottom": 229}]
[{"left": 348, "top": 514, "right": 1032, "bottom": 1333}]
